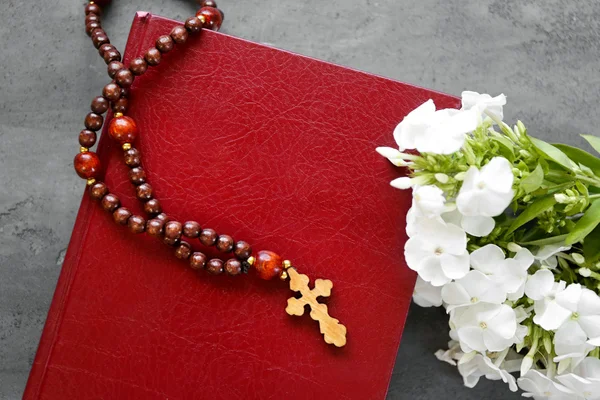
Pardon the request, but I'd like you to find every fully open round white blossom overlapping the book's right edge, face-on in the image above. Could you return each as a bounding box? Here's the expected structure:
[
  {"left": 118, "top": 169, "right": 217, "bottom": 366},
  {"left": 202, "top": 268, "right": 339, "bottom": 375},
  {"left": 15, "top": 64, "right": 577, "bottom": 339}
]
[{"left": 404, "top": 218, "right": 469, "bottom": 286}]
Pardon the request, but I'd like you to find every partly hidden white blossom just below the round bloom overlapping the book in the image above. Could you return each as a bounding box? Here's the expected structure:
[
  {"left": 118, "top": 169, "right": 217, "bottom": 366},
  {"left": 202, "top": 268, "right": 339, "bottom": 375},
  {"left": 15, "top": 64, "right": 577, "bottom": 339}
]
[{"left": 442, "top": 271, "right": 506, "bottom": 312}]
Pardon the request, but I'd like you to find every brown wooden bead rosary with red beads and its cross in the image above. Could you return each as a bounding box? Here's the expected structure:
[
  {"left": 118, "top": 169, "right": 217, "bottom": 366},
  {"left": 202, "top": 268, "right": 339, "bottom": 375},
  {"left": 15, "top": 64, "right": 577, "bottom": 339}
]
[{"left": 74, "top": 0, "right": 346, "bottom": 347}]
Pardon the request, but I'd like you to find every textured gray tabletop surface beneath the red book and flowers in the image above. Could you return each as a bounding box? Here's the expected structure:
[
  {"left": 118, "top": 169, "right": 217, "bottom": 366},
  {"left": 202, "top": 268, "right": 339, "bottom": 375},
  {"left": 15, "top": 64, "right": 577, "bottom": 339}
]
[{"left": 0, "top": 0, "right": 600, "bottom": 399}]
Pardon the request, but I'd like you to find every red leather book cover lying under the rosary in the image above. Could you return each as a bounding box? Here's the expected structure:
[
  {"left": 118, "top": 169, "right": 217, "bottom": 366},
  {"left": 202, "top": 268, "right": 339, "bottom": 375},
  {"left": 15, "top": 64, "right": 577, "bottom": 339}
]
[{"left": 24, "top": 13, "right": 458, "bottom": 400}]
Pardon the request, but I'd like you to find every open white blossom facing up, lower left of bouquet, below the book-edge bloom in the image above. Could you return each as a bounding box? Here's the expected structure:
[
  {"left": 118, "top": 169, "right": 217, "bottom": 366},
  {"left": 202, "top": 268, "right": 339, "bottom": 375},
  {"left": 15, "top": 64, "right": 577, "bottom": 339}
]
[{"left": 451, "top": 303, "right": 517, "bottom": 353}]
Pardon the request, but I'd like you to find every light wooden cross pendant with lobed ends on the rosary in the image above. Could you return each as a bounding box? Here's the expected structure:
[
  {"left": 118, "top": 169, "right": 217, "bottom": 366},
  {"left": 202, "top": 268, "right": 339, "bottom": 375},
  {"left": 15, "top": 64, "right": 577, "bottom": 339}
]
[{"left": 285, "top": 268, "right": 346, "bottom": 347}]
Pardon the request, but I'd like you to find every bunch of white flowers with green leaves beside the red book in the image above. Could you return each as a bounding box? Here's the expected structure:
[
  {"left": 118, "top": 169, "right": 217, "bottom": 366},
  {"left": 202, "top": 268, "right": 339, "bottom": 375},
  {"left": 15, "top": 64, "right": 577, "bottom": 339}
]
[{"left": 377, "top": 92, "right": 600, "bottom": 399}]
